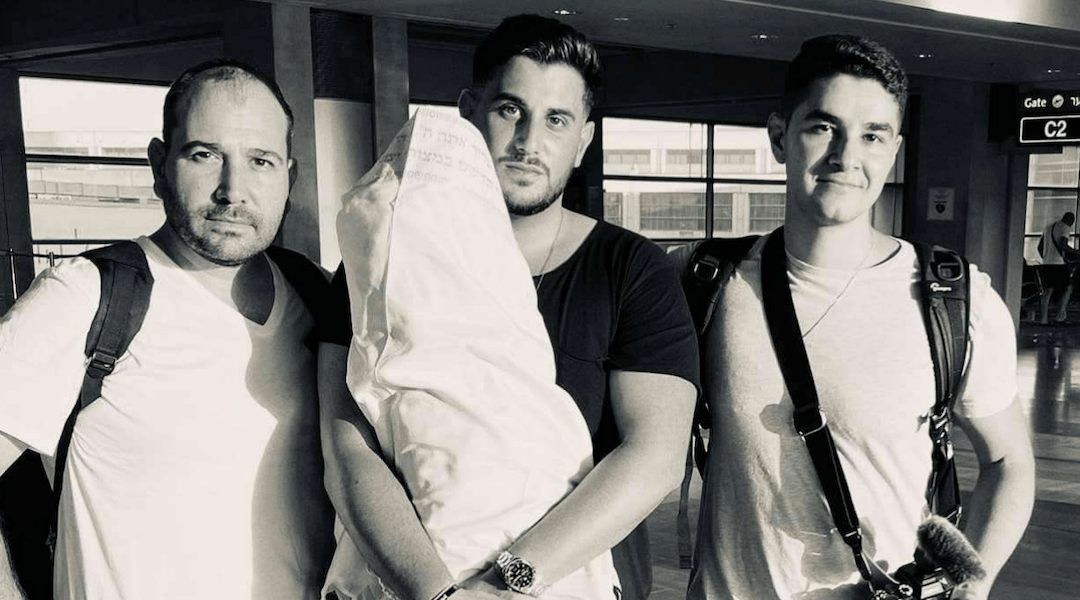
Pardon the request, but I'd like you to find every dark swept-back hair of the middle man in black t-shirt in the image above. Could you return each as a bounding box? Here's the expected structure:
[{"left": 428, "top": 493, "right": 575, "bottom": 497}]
[{"left": 473, "top": 14, "right": 600, "bottom": 114}]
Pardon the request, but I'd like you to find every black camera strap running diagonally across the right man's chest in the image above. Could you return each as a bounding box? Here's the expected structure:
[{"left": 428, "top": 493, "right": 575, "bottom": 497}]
[{"left": 761, "top": 228, "right": 870, "bottom": 581}]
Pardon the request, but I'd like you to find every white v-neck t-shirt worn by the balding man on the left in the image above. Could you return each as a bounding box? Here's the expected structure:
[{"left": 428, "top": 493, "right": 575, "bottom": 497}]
[{"left": 0, "top": 237, "right": 333, "bottom": 600}]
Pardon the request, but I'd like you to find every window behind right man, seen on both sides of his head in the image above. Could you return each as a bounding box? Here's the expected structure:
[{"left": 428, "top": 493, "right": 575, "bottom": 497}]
[{"left": 603, "top": 118, "right": 904, "bottom": 245}]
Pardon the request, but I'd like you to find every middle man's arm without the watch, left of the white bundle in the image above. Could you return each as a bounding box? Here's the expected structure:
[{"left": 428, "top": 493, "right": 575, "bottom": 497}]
[{"left": 313, "top": 343, "right": 496, "bottom": 600}]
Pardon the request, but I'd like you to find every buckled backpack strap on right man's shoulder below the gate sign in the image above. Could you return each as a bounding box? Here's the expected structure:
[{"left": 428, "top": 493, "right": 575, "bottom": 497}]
[{"left": 915, "top": 243, "right": 971, "bottom": 524}]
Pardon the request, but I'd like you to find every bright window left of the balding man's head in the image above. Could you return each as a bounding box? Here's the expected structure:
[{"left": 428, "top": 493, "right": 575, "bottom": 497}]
[{"left": 19, "top": 77, "right": 167, "bottom": 270}]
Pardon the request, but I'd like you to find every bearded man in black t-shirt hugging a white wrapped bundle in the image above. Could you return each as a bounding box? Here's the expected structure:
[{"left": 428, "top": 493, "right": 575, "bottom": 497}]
[{"left": 320, "top": 15, "right": 698, "bottom": 600}]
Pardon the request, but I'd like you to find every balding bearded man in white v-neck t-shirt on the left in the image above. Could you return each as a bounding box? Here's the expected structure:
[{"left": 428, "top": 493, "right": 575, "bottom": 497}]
[{"left": 0, "top": 62, "right": 333, "bottom": 599}]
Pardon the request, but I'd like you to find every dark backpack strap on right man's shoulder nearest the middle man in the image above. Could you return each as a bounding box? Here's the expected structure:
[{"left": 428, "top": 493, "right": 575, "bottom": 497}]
[{"left": 675, "top": 235, "right": 760, "bottom": 569}]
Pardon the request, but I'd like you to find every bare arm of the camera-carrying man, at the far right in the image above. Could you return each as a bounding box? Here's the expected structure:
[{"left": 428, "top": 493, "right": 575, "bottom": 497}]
[{"left": 957, "top": 400, "right": 1035, "bottom": 598}]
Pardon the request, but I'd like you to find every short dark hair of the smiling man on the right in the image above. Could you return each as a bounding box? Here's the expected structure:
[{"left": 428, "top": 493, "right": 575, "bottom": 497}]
[{"left": 781, "top": 35, "right": 907, "bottom": 121}]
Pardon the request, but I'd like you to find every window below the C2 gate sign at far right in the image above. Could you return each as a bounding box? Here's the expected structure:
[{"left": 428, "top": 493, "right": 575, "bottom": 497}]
[{"left": 1024, "top": 146, "right": 1080, "bottom": 264}]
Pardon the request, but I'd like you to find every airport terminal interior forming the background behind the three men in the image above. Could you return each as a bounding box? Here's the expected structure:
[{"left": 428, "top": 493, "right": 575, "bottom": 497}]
[{"left": 0, "top": 0, "right": 1080, "bottom": 600}]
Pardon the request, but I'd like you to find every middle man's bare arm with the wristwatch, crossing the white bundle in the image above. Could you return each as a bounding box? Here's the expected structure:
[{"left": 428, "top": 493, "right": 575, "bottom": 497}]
[{"left": 468, "top": 371, "right": 697, "bottom": 589}]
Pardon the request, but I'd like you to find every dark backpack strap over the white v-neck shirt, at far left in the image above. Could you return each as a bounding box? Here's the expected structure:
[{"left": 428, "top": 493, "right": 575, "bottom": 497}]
[{"left": 49, "top": 242, "right": 153, "bottom": 550}]
